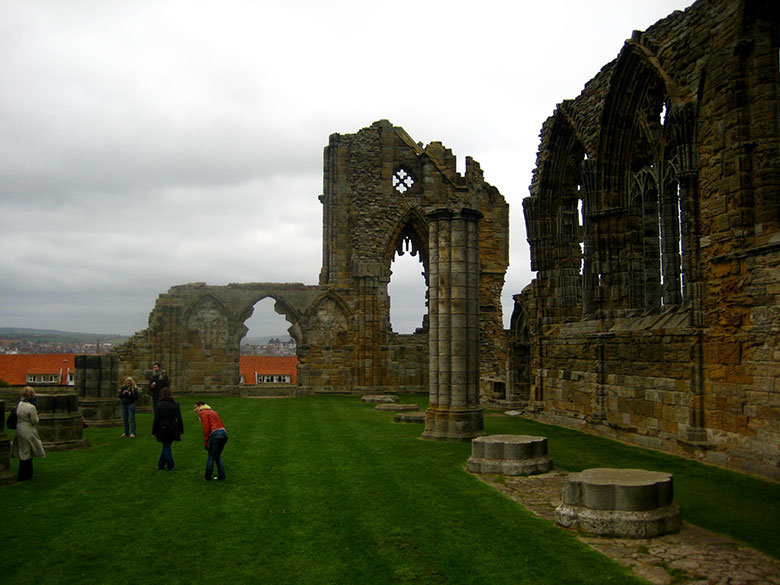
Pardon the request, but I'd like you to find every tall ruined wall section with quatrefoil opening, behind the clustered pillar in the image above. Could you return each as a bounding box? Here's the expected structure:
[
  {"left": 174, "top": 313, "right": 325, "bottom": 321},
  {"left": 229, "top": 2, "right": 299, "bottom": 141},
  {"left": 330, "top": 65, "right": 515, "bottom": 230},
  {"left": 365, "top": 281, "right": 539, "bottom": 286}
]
[{"left": 320, "top": 120, "right": 508, "bottom": 391}]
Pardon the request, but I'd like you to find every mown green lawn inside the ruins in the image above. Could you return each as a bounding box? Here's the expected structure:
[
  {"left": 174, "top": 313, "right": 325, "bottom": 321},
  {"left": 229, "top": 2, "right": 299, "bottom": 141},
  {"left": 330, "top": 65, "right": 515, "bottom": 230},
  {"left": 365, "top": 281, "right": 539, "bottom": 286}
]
[{"left": 0, "top": 396, "right": 780, "bottom": 585}]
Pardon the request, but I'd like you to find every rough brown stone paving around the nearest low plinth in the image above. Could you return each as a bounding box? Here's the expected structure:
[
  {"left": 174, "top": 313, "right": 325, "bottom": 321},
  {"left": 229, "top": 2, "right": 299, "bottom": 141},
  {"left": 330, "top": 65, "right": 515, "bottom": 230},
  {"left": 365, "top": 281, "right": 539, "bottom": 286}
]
[{"left": 477, "top": 469, "right": 780, "bottom": 585}]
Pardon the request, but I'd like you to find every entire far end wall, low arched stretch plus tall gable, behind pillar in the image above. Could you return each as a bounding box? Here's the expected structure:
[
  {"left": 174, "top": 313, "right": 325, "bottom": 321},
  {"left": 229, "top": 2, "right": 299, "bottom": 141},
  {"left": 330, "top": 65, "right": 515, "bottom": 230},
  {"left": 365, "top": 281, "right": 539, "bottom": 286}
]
[{"left": 112, "top": 120, "right": 508, "bottom": 426}]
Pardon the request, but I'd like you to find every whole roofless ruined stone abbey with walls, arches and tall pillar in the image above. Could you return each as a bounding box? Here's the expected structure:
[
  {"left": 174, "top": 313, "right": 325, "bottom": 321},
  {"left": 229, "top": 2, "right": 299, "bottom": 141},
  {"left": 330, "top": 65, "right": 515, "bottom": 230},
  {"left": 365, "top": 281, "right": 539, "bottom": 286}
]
[{"left": 100, "top": 0, "right": 780, "bottom": 479}]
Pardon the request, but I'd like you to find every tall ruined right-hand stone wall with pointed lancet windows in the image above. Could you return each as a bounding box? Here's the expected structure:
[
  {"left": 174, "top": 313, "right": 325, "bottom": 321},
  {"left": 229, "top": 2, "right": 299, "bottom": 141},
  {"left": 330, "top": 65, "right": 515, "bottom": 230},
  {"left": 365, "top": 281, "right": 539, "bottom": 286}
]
[{"left": 516, "top": 0, "right": 780, "bottom": 478}]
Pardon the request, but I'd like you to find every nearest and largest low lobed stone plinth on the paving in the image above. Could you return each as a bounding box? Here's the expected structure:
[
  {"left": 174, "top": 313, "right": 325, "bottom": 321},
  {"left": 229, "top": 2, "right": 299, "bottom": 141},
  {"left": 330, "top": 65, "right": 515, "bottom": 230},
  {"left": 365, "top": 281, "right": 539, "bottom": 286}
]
[{"left": 555, "top": 468, "right": 682, "bottom": 538}]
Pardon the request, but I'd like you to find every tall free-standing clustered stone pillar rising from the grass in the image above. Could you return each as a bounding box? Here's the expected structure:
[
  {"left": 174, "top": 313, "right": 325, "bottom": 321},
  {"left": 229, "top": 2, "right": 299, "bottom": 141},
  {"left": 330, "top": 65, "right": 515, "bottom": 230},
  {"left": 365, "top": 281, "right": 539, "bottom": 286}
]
[{"left": 422, "top": 209, "right": 483, "bottom": 441}]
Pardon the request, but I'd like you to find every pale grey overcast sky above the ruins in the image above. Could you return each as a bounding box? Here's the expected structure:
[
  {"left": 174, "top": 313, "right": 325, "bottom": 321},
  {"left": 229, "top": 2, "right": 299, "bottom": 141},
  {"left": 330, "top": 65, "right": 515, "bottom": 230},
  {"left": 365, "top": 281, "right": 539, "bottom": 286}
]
[{"left": 0, "top": 0, "right": 690, "bottom": 335}]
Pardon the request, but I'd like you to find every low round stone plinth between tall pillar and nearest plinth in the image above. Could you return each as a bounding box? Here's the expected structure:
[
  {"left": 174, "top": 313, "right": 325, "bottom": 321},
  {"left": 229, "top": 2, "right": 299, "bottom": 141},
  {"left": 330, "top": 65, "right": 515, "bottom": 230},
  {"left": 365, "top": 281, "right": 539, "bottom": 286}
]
[{"left": 466, "top": 435, "right": 552, "bottom": 475}]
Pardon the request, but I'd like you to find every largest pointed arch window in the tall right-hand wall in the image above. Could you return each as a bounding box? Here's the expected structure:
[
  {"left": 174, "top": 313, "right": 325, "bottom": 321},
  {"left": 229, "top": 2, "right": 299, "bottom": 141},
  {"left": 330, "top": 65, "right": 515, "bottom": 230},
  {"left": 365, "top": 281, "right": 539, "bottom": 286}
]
[{"left": 596, "top": 40, "right": 682, "bottom": 314}]
